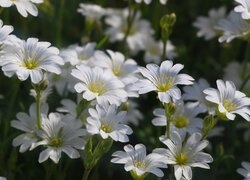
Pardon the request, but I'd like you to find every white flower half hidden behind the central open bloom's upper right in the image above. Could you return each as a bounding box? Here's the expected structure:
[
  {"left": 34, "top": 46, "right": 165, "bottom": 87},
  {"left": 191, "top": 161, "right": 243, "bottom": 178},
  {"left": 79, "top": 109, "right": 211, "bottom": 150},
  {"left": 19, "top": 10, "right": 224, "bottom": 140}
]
[{"left": 93, "top": 50, "right": 138, "bottom": 85}]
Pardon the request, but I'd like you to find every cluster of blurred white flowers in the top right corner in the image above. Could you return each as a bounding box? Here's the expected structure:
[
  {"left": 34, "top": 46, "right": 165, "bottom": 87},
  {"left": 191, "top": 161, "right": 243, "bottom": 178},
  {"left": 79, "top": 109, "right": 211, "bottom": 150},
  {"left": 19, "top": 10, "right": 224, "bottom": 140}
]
[{"left": 194, "top": 0, "right": 250, "bottom": 43}]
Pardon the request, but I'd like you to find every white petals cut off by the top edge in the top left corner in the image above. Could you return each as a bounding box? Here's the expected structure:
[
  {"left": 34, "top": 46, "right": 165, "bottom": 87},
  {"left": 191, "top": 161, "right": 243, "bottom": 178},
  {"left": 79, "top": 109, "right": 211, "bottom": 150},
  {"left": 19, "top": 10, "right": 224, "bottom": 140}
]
[{"left": 0, "top": 0, "right": 43, "bottom": 17}]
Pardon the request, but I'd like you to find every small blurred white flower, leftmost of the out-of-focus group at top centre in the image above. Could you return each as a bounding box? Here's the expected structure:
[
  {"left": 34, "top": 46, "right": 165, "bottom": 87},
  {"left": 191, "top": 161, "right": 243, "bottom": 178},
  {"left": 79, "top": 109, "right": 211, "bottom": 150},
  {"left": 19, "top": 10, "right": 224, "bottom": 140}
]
[{"left": 77, "top": 3, "right": 105, "bottom": 21}]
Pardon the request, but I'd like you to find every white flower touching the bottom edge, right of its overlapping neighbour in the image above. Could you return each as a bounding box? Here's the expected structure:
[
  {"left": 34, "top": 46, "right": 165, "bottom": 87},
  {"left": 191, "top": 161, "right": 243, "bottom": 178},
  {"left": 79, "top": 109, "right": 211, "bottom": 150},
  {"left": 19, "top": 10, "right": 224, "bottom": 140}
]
[{"left": 153, "top": 132, "right": 213, "bottom": 180}]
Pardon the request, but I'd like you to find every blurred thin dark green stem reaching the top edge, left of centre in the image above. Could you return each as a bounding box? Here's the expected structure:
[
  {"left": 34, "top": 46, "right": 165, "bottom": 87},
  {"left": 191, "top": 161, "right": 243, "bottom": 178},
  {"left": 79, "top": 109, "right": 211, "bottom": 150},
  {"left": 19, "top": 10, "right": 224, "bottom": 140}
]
[{"left": 56, "top": 0, "right": 65, "bottom": 48}]
